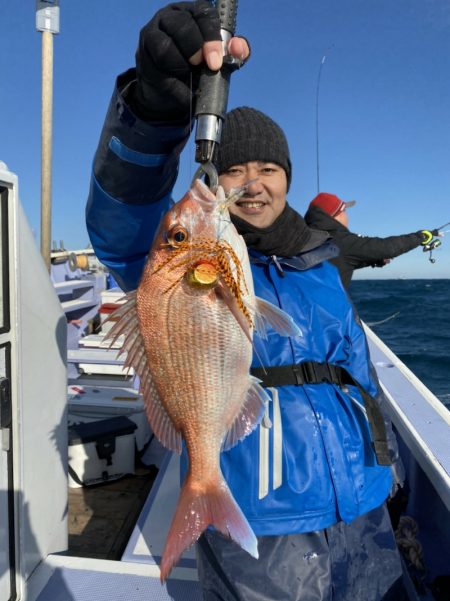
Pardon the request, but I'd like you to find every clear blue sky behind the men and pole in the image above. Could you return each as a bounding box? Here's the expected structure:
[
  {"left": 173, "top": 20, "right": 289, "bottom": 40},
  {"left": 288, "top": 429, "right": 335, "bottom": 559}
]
[{"left": 0, "top": 0, "right": 450, "bottom": 278}]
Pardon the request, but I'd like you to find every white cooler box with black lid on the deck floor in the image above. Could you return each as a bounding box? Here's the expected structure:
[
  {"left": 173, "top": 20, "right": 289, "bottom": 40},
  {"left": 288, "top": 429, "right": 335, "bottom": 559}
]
[{"left": 69, "top": 416, "right": 137, "bottom": 488}]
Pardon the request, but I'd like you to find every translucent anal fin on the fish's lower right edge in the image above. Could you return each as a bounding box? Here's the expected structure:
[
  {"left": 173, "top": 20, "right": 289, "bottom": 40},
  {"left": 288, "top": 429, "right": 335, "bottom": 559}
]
[{"left": 222, "top": 376, "right": 270, "bottom": 451}]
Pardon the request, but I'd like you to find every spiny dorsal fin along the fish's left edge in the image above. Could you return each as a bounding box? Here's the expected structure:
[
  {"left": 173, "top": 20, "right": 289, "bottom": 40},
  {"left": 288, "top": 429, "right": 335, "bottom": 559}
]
[{"left": 105, "top": 291, "right": 182, "bottom": 454}]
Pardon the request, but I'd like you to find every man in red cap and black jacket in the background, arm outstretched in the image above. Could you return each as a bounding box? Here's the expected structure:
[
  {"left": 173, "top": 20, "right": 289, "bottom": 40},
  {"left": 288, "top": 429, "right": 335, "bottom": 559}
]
[{"left": 305, "top": 192, "right": 439, "bottom": 288}]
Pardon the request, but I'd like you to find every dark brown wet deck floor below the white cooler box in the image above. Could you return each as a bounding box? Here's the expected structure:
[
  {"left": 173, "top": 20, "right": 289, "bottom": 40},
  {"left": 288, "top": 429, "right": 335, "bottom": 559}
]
[{"left": 68, "top": 465, "right": 158, "bottom": 560}]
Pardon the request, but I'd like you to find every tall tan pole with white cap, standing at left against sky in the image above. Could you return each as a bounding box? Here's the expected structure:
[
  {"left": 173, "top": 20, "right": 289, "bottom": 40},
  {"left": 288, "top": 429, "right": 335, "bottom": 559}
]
[{"left": 36, "top": 0, "right": 59, "bottom": 271}]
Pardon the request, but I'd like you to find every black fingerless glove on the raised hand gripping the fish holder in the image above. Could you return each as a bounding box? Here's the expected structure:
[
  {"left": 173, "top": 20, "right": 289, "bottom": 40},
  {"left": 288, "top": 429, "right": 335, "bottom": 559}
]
[{"left": 127, "top": 0, "right": 221, "bottom": 123}]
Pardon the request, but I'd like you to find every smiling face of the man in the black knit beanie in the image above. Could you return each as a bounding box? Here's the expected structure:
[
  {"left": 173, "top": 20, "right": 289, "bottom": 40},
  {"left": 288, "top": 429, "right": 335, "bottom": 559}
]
[{"left": 219, "top": 161, "right": 287, "bottom": 228}]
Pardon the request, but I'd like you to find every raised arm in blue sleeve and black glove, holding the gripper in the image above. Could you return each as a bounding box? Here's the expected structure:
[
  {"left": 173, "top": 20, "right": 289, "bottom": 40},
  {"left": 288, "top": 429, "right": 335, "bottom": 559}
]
[{"left": 86, "top": 0, "right": 249, "bottom": 290}]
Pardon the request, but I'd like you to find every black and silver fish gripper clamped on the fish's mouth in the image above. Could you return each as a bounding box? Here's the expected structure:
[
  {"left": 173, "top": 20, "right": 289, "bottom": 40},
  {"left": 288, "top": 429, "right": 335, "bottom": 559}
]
[{"left": 194, "top": 0, "right": 242, "bottom": 190}]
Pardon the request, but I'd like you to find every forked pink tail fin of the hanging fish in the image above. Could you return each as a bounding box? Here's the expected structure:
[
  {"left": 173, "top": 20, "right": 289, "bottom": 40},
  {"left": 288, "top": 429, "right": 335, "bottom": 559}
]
[{"left": 160, "top": 478, "right": 258, "bottom": 582}]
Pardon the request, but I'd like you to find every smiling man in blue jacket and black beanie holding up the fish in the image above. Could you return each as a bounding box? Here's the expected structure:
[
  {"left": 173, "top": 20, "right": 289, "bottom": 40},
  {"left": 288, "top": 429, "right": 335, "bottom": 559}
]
[{"left": 87, "top": 1, "right": 403, "bottom": 601}]
